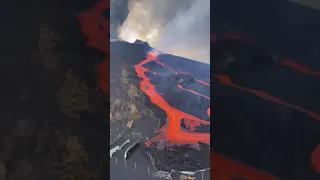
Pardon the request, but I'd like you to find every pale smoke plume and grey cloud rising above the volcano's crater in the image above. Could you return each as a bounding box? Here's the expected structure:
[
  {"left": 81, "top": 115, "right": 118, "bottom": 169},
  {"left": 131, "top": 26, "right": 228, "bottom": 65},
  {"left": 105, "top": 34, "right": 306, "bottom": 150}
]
[{"left": 118, "top": 0, "right": 210, "bottom": 64}]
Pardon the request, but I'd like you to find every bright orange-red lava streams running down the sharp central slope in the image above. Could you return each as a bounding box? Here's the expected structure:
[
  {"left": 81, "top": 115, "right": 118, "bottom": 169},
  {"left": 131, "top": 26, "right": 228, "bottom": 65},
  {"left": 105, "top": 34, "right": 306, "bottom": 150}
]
[{"left": 134, "top": 53, "right": 210, "bottom": 147}]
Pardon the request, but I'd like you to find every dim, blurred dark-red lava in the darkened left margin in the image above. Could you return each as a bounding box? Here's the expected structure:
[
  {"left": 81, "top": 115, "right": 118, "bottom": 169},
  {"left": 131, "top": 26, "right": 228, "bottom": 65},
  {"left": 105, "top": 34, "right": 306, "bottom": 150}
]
[{"left": 78, "top": 0, "right": 110, "bottom": 94}]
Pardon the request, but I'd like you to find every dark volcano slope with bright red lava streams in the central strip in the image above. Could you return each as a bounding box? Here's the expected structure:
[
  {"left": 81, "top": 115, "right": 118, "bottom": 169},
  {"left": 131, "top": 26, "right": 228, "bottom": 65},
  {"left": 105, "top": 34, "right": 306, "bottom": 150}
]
[{"left": 110, "top": 40, "right": 210, "bottom": 171}]
